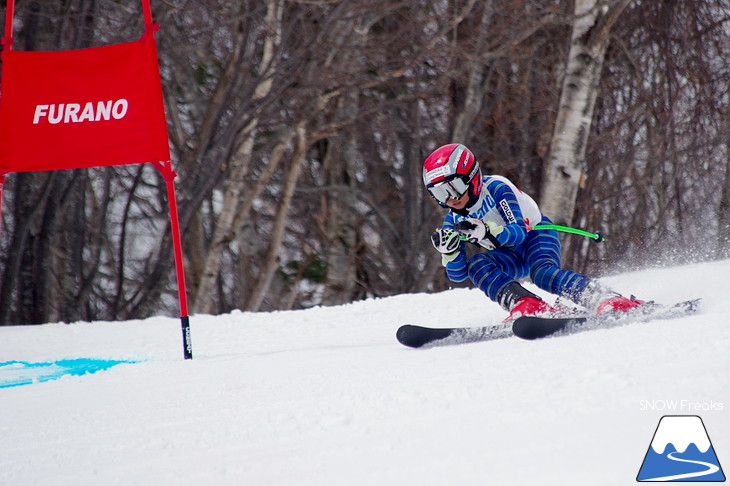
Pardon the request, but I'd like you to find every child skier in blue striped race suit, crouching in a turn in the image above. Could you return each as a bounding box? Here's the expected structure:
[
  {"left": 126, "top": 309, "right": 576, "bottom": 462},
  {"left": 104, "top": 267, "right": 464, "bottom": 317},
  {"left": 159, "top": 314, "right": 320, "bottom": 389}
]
[{"left": 423, "top": 143, "right": 642, "bottom": 319}]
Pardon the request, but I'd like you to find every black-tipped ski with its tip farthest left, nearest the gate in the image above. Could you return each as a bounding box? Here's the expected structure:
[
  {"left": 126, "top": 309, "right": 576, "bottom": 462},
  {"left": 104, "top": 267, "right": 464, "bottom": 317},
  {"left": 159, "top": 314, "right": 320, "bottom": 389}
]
[{"left": 395, "top": 323, "right": 512, "bottom": 348}]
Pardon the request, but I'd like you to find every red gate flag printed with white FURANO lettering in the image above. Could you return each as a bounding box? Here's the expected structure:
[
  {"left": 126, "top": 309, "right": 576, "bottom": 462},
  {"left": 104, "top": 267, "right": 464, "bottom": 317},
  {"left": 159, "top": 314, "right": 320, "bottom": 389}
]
[{"left": 0, "top": 31, "right": 170, "bottom": 174}]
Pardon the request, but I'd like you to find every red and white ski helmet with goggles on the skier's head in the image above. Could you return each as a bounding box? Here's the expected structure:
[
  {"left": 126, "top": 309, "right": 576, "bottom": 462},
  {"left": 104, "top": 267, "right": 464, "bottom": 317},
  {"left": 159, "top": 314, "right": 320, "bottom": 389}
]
[{"left": 423, "top": 143, "right": 482, "bottom": 208}]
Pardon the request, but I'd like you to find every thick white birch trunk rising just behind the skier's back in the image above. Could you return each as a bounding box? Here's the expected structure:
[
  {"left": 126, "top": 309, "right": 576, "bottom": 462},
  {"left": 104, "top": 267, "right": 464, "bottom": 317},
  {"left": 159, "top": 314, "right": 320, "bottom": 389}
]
[{"left": 540, "top": 0, "right": 631, "bottom": 224}]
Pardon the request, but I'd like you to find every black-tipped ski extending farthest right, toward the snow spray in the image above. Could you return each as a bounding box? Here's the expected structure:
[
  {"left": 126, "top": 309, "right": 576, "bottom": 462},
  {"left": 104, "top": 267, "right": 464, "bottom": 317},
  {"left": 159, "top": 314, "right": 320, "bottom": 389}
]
[{"left": 512, "top": 299, "right": 701, "bottom": 340}]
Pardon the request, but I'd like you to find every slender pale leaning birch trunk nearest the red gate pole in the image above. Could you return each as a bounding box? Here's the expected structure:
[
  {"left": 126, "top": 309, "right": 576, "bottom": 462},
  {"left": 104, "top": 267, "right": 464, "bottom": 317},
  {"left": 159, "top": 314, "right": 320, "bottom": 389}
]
[{"left": 193, "top": 0, "right": 283, "bottom": 314}]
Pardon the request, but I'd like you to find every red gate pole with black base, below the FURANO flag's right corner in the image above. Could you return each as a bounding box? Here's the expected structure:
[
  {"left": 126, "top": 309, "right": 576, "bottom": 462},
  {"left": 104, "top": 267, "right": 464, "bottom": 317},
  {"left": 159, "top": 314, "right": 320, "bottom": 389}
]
[{"left": 155, "top": 161, "right": 193, "bottom": 359}]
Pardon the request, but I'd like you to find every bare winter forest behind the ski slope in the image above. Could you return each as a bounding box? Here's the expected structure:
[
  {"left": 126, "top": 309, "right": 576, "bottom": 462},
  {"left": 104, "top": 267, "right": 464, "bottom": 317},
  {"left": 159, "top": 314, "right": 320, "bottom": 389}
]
[{"left": 0, "top": 0, "right": 730, "bottom": 324}]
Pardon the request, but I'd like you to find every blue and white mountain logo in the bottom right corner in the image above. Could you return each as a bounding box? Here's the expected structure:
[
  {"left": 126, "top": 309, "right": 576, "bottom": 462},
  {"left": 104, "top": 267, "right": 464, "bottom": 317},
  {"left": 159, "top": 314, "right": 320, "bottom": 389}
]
[{"left": 636, "top": 415, "right": 725, "bottom": 482}]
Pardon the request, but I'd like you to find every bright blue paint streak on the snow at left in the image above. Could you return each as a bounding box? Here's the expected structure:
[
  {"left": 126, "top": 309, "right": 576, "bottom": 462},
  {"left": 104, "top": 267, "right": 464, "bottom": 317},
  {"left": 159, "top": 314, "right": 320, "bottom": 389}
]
[{"left": 0, "top": 358, "right": 136, "bottom": 388}]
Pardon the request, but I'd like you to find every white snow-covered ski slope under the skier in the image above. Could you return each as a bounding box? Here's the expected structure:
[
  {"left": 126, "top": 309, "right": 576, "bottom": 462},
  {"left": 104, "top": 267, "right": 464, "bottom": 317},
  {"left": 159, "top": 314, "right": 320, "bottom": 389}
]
[{"left": 0, "top": 261, "right": 730, "bottom": 486}]
